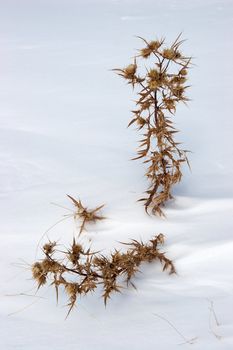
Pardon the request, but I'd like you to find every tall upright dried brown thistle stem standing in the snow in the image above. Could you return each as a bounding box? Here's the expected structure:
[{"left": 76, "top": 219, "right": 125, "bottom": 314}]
[{"left": 113, "top": 34, "right": 191, "bottom": 216}]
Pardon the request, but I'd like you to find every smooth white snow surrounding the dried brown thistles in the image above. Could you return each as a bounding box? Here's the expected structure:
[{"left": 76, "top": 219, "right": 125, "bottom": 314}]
[{"left": 0, "top": 0, "right": 233, "bottom": 350}]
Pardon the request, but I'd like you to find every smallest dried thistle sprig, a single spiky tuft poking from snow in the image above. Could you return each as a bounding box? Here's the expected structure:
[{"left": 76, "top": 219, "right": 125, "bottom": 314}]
[{"left": 67, "top": 194, "right": 105, "bottom": 235}]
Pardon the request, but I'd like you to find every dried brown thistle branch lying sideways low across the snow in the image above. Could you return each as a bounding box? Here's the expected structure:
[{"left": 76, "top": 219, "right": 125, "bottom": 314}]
[{"left": 32, "top": 234, "right": 175, "bottom": 316}]
